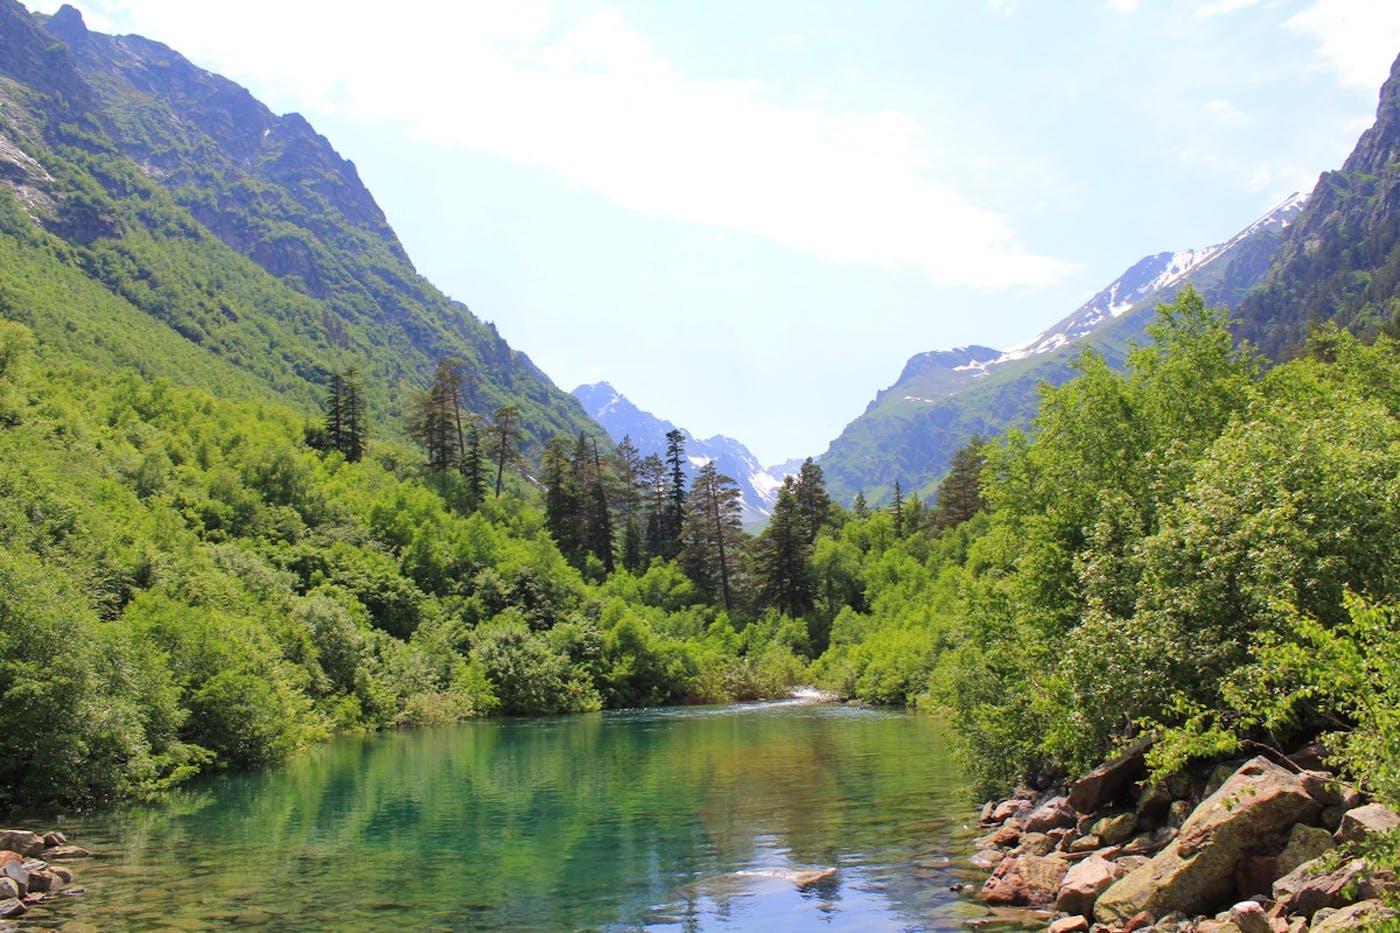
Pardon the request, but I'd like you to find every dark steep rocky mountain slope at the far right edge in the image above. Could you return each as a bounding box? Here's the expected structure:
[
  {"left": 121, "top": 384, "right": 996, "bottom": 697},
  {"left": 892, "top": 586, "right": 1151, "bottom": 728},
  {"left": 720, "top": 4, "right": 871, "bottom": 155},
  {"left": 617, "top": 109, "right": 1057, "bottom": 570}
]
[{"left": 1238, "top": 50, "right": 1400, "bottom": 360}]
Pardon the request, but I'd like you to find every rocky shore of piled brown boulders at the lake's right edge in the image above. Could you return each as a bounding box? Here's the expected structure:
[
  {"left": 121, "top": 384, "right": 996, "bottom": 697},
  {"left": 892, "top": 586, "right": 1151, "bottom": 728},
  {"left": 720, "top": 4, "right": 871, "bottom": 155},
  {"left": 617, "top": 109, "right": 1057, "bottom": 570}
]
[{"left": 972, "top": 741, "right": 1400, "bottom": 933}]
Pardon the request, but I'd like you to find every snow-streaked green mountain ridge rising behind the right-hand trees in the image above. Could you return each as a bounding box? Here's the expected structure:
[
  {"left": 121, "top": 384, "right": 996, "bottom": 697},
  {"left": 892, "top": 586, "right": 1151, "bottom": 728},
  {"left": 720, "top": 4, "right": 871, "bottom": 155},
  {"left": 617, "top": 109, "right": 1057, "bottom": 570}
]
[{"left": 819, "top": 195, "right": 1308, "bottom": 504}]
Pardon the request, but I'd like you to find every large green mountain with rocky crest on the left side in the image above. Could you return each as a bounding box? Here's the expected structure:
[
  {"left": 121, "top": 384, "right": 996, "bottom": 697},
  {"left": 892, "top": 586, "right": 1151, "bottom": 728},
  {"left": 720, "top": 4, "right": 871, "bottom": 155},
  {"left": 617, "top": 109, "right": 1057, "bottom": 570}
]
[{"left": 0, "top": 0, "right": 601, "bottom": 448}]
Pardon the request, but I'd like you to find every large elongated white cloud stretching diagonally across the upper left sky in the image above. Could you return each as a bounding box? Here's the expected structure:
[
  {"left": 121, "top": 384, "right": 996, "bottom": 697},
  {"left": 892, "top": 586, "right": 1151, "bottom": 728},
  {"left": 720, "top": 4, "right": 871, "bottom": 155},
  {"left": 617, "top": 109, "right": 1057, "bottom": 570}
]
[{"left": 32, "top": 0, "right": 1068, "bottom": 287}]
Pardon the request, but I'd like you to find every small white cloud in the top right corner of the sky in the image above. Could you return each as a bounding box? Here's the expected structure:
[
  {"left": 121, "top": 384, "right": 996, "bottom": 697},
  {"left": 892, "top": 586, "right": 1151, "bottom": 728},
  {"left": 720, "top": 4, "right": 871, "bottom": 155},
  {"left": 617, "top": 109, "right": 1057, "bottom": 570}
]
[{"left": 1285, "top": 0, "right": 1400, "bottom": 90}]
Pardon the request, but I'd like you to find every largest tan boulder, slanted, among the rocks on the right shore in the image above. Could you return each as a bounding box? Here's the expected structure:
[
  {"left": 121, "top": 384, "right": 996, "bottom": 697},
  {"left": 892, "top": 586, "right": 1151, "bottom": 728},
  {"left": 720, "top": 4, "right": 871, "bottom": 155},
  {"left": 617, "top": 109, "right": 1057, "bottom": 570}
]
[{"left": 1093, "top": 756, "right": 1322, "bottom": 926}]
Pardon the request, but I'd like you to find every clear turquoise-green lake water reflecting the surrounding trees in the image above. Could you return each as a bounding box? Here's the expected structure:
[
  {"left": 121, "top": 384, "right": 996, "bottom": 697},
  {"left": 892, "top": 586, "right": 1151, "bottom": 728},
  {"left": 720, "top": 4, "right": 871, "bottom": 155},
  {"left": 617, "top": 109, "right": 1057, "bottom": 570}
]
[{"left": 29, "top": 702, "right": 983, "bottom": 933}]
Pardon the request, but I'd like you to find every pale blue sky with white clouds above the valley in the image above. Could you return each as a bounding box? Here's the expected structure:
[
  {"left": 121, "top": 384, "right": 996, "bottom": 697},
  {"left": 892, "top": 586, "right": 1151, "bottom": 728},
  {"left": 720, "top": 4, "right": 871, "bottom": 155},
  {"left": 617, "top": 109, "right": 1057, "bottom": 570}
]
[{"left": 29, "top": 0, "right": 1400, "bottom": 464}]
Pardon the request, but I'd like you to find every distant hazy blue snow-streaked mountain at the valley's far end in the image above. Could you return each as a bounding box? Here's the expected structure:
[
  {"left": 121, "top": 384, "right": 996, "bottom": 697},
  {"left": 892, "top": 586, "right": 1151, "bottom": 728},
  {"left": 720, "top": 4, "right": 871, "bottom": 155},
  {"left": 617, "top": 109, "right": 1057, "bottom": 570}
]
[{"left": 574, "top": 382, "right": 801, "bottom": 524}]
